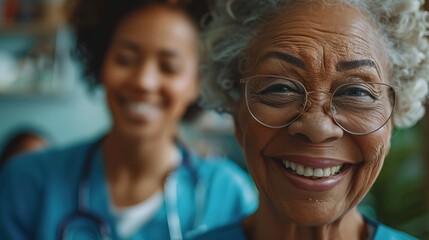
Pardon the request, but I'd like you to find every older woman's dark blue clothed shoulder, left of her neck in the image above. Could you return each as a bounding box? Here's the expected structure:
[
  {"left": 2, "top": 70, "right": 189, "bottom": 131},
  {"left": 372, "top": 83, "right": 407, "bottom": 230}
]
[{"left": 191, "top": 221, "right": 246, "bottom": 240}]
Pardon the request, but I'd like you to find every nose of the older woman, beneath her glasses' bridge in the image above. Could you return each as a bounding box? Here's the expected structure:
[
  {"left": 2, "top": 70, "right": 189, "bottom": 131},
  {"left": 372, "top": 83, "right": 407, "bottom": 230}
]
[{"left": 288, "top": 92, "right": 344, "bottom": 143}]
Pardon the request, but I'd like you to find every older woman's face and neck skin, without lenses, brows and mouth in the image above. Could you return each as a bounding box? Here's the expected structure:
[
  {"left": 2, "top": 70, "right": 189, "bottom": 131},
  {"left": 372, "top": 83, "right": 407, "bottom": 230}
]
[{"left": 235, "top": 2, "right": 392, "bottom": 239}]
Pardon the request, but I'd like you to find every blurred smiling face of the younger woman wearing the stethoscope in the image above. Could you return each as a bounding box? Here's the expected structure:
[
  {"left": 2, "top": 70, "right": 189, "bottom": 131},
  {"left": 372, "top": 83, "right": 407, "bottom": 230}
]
[{"left": 102, "top": 5, "right": 198, "bottom": 138}]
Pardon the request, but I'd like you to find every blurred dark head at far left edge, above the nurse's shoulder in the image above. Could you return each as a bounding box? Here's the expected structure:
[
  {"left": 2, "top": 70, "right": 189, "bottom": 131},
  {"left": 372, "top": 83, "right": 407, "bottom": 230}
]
[{"left": 0, "top": 127, "right": 49, "bottom": 169}]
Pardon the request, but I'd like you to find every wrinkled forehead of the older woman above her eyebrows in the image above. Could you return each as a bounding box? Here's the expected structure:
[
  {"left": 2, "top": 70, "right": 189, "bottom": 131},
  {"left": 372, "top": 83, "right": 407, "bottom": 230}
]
[{"left": 247, "top": 1, "right": 388, "bottom": 81}]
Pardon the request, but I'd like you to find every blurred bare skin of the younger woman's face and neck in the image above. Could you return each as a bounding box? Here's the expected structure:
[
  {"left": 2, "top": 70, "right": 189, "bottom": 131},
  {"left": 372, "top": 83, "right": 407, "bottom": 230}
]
[{"left": 101, "top": 5, "right": 198, "bottom": 207}]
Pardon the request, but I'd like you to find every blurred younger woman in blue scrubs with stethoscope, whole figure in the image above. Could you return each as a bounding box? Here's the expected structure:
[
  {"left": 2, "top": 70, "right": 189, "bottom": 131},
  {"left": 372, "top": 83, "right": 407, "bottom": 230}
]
[{"left": 0, "top": 0, "right": 257, "bottom": 240}]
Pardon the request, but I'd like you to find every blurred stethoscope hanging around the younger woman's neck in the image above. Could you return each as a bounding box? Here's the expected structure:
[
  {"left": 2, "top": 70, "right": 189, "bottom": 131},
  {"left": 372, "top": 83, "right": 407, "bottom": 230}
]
[{"left": 57, "top": 139, "right": 205, "bottom": 240}]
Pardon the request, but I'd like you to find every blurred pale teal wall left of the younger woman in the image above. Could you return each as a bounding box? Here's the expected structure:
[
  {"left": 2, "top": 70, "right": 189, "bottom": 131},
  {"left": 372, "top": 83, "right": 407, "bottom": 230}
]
[{"left": 0, "top": 29, "right": 110, "bottom": 150}]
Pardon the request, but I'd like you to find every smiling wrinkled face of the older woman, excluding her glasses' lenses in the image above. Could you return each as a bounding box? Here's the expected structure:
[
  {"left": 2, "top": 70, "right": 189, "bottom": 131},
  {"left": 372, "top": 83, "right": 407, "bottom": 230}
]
[{"left": 235, "top": 2, "right": 392, "bottom": 226}]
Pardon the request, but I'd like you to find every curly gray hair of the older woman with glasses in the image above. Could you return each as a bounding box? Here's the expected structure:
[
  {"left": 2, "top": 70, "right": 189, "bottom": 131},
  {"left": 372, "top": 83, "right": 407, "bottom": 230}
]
[{"left": 201, "top": 0, "right": 429, "bottom": 127}]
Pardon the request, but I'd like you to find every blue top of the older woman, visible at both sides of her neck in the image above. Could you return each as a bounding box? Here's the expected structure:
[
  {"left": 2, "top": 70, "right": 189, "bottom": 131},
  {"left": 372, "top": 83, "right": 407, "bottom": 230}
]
[{"left": 192, "top": 220, "right": 416, "bottom": 240}]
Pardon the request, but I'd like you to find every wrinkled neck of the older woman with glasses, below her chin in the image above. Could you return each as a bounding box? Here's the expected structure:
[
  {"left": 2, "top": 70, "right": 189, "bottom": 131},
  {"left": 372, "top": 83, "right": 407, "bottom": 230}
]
[{"left": 242, "top": 200, "right": 367, "bottom": 240}]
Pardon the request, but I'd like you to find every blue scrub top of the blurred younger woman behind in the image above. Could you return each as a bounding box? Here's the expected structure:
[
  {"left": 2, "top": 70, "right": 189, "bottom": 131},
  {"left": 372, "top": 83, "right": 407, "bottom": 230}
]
[{"left": 0, "top": 138, "right": 257, "bottom": 240}]
